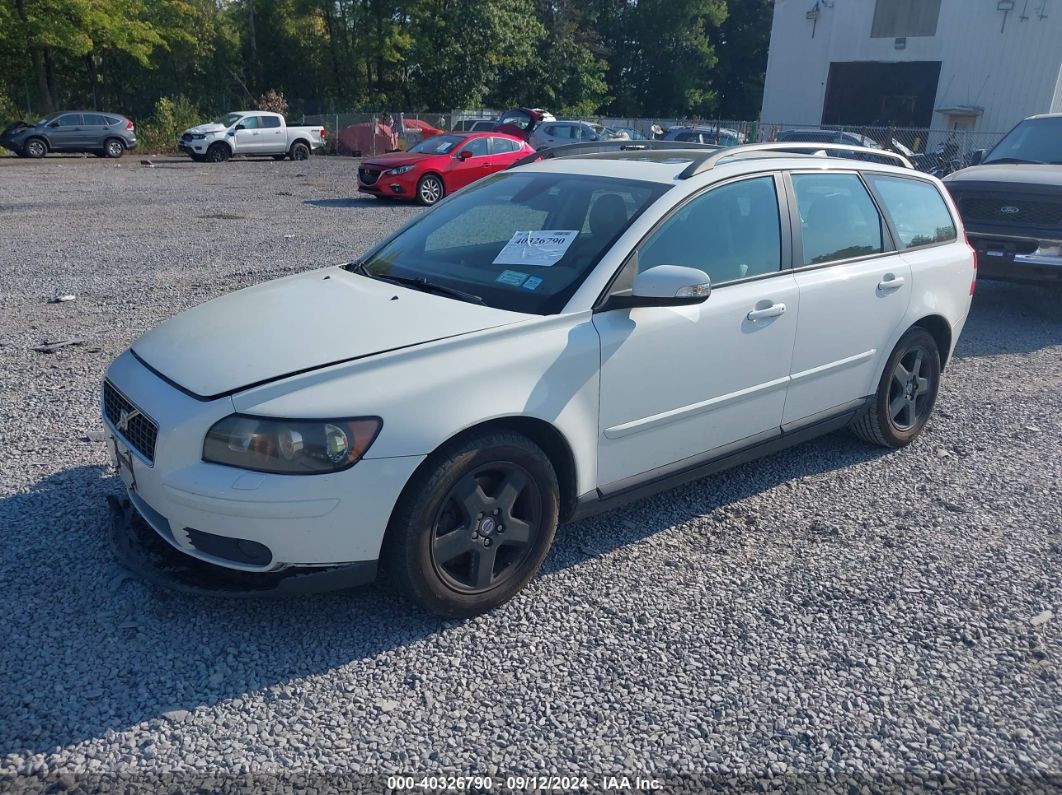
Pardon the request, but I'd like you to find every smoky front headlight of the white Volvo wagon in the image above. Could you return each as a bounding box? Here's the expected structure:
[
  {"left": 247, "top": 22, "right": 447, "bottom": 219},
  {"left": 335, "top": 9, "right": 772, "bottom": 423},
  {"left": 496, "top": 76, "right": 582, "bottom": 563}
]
[{"left": 203, "top": 414, "right": 383, "bottom": 474}]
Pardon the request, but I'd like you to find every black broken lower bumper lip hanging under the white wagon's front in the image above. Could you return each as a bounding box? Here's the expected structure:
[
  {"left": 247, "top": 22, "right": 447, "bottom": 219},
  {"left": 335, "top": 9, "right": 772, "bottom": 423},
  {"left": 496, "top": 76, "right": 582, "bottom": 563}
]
[{"left": 107, "top": 496, "right": 377, "bottom": 598}]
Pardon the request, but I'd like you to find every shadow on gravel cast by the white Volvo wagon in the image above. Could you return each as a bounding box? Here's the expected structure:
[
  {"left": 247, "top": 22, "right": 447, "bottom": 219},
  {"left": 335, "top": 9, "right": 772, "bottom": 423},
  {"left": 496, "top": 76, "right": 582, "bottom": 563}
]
[{"left": 0, "top": 434, "right": 883, "bottom": 756}]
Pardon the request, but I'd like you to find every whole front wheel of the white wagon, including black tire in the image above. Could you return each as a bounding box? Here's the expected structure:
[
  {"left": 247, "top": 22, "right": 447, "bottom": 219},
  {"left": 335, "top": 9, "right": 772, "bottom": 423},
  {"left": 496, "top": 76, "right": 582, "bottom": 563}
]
[{"left": 382, "top": 431, "right": 560, "bottom": 618}]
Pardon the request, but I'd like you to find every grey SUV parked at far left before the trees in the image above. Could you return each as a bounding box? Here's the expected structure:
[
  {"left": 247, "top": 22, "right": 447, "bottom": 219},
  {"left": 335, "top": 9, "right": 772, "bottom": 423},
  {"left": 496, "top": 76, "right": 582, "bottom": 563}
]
[{"left": 0, "top": 110, "right": 136, "bottom": 158}]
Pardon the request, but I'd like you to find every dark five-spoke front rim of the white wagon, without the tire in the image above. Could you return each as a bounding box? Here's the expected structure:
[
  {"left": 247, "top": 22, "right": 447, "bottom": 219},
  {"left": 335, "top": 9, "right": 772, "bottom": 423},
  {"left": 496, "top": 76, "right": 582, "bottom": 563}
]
[{"left": 431, "top": 463, "right": 542, "bottom": 594}]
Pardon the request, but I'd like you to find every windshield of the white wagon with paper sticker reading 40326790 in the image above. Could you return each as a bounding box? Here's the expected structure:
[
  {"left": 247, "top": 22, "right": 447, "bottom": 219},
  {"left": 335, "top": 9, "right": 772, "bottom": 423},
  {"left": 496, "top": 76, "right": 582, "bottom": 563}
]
[{"left": 352, "top": 172, "right": 668, "bottom": 314}]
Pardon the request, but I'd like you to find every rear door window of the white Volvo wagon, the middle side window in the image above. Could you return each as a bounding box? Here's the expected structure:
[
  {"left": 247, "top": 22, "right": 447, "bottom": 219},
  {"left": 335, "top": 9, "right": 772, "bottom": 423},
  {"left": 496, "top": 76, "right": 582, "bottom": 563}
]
[{"left": 792, "top": 174, "right": 885, "bottom": 265}]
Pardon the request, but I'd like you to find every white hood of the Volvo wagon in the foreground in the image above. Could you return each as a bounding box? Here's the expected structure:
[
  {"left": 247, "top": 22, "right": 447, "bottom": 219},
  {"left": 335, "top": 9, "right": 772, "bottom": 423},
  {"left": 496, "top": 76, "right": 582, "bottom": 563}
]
[{"left": 133, "top": 267, "right": 528, "bottom": 398}]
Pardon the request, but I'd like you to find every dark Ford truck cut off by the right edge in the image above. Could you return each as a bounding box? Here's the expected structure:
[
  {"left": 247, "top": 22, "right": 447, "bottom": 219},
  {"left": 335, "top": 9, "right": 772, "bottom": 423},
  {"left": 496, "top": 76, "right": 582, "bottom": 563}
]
[{"left": 944, "top": 114, "right": 1062, "bottom": 284}]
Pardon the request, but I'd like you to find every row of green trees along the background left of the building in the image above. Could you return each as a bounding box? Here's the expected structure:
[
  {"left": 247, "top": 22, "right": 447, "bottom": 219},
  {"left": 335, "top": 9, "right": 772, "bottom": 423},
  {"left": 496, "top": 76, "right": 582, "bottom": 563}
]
[{"left": 0, "top": 0, "right": 773, "bottom": 119}]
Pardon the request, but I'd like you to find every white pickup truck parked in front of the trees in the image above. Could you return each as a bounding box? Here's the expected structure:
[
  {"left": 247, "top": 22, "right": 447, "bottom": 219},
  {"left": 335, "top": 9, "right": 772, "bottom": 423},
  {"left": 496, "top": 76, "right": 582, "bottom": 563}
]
[{"left": 177, "top": 110, "right": 326, "bottom": 162}]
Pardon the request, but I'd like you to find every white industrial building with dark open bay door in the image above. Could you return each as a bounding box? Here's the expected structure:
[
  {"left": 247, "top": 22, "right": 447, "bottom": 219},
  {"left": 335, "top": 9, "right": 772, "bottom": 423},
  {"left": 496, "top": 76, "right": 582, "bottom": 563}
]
[{"left": 760, "top": 0, "right": 1062, "bottom": 133}]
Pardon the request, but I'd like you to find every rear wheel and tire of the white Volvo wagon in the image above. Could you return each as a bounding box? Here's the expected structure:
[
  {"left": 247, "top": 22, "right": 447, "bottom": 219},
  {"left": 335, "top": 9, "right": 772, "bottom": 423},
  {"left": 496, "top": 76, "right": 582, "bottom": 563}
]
[{"left": 851, "top": 326, "right": 940, "bottom": 449}]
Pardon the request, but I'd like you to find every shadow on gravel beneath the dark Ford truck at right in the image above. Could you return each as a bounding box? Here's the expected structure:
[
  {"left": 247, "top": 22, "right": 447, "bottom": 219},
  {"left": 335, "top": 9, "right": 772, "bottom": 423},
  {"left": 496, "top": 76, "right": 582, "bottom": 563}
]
[{"left": 955, "top": 281, "right": 1062, "bottom": 358}]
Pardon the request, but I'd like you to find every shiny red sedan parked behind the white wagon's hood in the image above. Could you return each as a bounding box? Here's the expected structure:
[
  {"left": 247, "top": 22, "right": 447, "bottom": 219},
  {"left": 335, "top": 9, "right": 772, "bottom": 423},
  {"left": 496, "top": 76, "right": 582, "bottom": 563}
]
[{"left": 358, "top": 133, "right": 534, "bottom": 205}]
